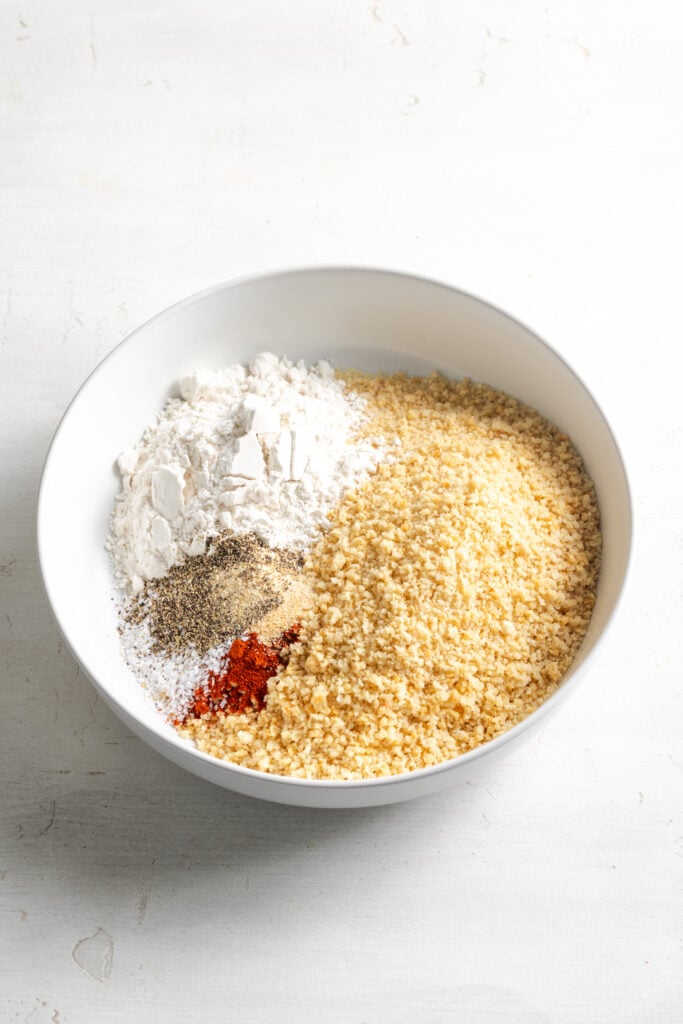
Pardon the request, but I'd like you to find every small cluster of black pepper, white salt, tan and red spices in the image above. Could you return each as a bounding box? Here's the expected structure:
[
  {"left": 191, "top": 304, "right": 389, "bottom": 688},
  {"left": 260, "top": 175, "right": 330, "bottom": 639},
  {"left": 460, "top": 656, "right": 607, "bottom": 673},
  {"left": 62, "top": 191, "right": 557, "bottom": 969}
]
[{"left": 120, "top": 535, "right": 311, "bottom": 724}]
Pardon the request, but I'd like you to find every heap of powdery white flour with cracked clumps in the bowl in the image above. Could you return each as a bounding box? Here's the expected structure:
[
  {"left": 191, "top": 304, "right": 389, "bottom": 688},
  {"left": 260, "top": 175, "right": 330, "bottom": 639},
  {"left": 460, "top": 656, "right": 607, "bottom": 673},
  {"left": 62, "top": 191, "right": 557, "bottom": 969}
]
[{"left": 108, "top": 353, "right": 384, "bottom": 594}]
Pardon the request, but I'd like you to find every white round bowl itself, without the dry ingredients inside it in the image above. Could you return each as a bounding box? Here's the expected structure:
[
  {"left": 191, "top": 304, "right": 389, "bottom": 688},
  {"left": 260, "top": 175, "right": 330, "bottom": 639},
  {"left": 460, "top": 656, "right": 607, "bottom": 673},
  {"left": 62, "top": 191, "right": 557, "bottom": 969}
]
[{"left": 38, "top": 268, "right": 632, "bottom": 807}]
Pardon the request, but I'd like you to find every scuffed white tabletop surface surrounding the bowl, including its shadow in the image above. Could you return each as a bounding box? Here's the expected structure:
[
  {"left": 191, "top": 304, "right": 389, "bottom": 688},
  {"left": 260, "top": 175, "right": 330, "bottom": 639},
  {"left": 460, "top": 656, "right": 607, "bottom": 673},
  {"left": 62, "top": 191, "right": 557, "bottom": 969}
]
[{"left": 0, "top": 0, "right": 683, "bottom": 1024}]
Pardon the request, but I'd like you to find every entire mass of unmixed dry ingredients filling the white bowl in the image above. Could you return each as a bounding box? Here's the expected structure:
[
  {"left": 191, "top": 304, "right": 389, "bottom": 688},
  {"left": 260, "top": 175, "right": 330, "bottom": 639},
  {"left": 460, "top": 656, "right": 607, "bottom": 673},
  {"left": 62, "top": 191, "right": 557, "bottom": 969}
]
[{"left": 110, "top": 355, "right": 601, "bottom": 779}]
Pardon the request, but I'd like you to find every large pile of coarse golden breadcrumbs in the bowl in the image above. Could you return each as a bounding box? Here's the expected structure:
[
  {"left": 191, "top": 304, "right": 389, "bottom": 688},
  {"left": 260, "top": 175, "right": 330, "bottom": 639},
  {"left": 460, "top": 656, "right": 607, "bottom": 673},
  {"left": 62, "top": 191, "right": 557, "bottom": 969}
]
[{"left": 182, "top": 371, "right": 601, "bottom": 779}]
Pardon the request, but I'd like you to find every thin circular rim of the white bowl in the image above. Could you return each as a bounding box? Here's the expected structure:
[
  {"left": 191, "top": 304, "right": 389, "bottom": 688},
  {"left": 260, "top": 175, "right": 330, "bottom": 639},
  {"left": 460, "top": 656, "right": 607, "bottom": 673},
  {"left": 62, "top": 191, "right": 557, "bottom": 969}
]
[{"left": 36, "top": 263, "right": 635, "bottom": 792}]
